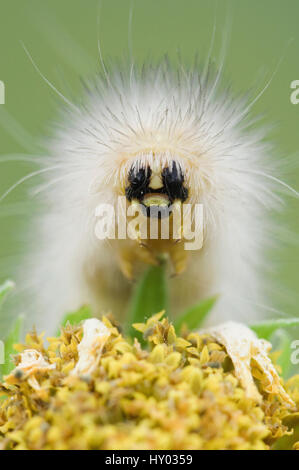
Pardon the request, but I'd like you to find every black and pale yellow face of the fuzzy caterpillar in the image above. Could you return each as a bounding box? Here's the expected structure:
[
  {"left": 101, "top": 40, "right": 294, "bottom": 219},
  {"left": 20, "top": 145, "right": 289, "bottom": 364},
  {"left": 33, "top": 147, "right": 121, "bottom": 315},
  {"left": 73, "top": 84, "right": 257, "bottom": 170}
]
[{"left": 125, "top": 161, "right": 189, "bottom": 218}]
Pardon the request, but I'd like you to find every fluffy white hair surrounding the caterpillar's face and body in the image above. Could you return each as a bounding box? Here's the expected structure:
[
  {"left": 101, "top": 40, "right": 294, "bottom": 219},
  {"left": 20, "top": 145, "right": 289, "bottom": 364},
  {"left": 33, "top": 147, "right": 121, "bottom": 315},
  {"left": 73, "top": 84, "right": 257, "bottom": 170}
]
[{"left": 11, "top": 61, "right": 279, "bottom": 331}]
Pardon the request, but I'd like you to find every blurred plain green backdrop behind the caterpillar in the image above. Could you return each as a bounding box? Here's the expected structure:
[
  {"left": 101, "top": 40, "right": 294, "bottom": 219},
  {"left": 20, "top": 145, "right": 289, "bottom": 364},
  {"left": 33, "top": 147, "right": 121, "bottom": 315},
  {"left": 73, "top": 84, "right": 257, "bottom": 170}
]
[{"left": 0, "top": 0, "right": 299, "bottom": 316}]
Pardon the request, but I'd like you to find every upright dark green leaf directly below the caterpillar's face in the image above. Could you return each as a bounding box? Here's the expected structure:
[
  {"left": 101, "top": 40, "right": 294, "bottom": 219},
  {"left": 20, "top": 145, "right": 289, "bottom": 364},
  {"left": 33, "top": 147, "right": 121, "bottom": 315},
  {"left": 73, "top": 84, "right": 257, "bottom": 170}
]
[{"left": 126, "top": 264, "right": 169, "bottom": 338}]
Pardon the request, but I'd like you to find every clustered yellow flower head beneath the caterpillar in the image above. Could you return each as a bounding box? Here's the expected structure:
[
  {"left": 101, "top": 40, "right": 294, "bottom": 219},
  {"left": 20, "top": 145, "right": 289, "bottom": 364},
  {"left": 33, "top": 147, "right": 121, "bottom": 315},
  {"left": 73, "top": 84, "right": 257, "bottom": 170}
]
[{"left": 0, "top": 312, "right": 299, "bottom": 450}]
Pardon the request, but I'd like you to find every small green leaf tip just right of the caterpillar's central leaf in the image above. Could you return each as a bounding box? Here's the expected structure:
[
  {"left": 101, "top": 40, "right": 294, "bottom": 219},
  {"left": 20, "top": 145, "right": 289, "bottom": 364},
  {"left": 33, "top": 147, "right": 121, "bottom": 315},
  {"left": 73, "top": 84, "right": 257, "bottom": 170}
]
[{"left": 174, "top": 295, "right": 218, "bottom": 332}]
